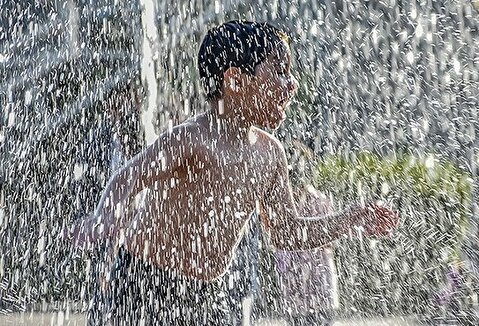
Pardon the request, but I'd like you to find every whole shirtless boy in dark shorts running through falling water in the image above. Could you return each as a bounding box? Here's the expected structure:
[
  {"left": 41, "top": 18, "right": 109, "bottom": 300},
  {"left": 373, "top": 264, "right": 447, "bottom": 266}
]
[{"left": 71, "top": 21, "right": 398, "bottom": 325}]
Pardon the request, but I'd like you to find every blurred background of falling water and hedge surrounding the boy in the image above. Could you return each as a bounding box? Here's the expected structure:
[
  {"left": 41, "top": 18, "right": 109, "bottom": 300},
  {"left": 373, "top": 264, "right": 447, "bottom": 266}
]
[{"left": 0, "top": 0, "right": 479, "bottom": 325}]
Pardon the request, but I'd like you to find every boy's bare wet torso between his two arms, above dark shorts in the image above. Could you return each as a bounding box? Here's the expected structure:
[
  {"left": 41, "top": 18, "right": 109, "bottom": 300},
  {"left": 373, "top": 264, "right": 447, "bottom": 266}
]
[{"left": 127, "top": 118, "right": 277, "bottom": 279}]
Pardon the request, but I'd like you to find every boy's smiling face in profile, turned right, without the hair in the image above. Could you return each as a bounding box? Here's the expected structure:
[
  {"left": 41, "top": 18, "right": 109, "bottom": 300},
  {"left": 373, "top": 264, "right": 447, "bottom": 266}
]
[{"left": 244, "top": 41, "right": 297, "bottom": 129}]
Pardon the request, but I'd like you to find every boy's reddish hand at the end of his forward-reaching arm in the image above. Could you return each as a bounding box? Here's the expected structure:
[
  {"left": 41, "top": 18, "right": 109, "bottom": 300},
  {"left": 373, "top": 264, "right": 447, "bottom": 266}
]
[{"left": 361, "top": 203, "right": 399, "bottom": 236}]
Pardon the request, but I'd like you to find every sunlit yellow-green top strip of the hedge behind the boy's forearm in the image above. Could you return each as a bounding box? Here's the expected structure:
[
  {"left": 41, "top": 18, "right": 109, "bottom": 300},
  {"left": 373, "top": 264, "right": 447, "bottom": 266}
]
[{"left": 315, "top": 152, "right": 472, "bottom": 203}]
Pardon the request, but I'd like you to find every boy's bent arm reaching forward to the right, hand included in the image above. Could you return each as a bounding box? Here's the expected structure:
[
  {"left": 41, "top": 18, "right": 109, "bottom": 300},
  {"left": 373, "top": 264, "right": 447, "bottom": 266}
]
[{"left": 261, "top": 141, "right": 399, "bottom": 250}]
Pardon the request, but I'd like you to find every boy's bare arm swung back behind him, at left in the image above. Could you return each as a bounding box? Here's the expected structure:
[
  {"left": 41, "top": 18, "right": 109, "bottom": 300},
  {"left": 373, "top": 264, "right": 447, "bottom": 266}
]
[{"left": 66, "top": 125, "right": 198, "bottom": 247}]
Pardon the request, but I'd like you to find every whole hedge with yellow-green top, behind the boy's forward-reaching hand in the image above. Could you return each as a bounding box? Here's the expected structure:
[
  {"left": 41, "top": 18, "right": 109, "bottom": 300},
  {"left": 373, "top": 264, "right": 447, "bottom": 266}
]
[{"left": 314, "top": 152, "right": 472, "bottom": 315}]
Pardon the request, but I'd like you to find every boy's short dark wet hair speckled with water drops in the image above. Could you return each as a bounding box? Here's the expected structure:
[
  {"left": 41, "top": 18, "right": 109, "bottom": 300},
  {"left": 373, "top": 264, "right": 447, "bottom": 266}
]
[{"left": 198, "top": 20, "right": 289, "bottom": 100}]
